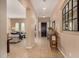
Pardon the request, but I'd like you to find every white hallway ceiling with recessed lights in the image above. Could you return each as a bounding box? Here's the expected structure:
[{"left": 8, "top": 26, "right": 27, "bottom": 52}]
[{"left": 31, "top": 0, "right": 59, "bottom": 17}]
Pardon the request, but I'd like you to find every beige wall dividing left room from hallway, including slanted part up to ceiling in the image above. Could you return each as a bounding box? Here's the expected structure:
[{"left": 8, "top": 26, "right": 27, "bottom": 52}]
[{"left": 19, "top": 0, "right": 38, "bottom": 48}]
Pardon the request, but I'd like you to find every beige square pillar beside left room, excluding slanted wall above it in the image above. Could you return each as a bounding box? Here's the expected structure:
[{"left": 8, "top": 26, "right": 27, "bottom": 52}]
[{"left": 26, "top": 8, "right": 37, "bottom": 48}]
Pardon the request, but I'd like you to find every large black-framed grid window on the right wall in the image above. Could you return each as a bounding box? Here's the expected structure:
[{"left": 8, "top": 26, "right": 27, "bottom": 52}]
[{"left": 62, "top": 0, "right": 79, "bottom": 31}]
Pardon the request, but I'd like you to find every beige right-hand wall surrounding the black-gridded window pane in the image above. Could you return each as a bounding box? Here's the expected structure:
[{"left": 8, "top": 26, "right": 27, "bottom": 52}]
[{"left": 52, "top": 0, "right": 79, "bottom": 57}]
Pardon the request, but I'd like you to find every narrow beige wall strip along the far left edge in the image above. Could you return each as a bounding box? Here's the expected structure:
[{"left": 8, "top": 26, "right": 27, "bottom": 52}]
[{"left": 0, "top": 0, "right": 7, "bottom": 58}]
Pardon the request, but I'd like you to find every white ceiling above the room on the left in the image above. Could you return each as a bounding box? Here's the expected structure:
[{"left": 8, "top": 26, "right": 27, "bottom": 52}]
[{"left": 7, "top": 0, "right": 26, "bottom": 18}]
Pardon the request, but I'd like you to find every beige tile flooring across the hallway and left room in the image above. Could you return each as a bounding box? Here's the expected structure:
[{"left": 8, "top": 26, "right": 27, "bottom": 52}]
[{"left": 8, "top": 38, "right": 63, "bottom": 58}]
